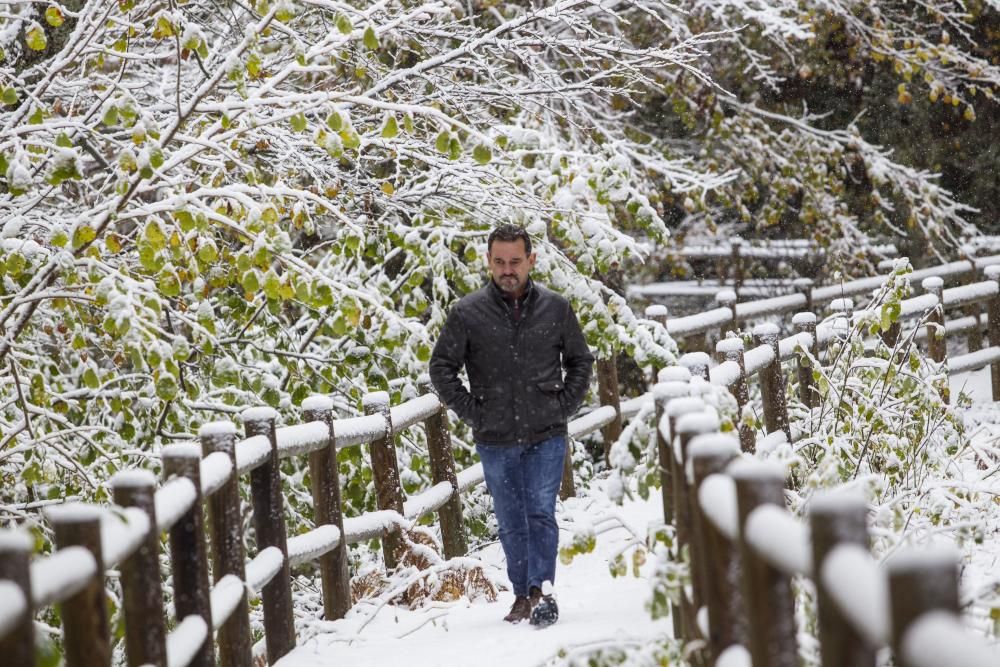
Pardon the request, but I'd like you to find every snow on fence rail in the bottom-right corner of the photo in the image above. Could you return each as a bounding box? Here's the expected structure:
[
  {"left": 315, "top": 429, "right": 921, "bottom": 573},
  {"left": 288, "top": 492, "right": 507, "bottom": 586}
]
[{"left": 900, "top": 611, "right": 1000, "bottom": 667}]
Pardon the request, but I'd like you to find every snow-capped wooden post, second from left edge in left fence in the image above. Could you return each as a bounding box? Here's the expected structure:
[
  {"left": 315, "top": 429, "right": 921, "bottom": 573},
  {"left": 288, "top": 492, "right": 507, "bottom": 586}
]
[{"left": 46, "top": 503, "right": 111, "bottom": 667}]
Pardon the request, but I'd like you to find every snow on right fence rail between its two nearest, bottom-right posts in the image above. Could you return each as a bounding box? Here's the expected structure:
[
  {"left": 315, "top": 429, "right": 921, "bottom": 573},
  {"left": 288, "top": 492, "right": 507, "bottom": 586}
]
[{"left": 819, "top": 544, "right": 890, "bottom": 646}]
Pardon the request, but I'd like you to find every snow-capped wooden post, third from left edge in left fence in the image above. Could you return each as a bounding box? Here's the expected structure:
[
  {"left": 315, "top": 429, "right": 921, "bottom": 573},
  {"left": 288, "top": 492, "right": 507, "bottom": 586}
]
[{"left": 111, "top": 470, "right": 167, "bottom": 667}]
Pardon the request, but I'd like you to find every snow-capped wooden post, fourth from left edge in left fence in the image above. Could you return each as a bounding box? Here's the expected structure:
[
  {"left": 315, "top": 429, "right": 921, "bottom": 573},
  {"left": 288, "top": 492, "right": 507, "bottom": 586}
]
[{"left": 160, "top": 443, "right": 215, "bottom": 667}]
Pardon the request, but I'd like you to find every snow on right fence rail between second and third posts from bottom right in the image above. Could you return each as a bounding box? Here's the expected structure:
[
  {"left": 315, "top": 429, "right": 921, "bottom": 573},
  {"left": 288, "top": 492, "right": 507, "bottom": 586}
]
[{"left": 745, "top": 504, "right": 812, "bottom": 576}]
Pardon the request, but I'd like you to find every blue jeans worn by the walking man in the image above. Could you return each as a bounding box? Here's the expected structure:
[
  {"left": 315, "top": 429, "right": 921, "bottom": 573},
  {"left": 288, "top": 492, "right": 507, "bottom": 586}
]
[{"left": 476, "top": 435, "right": 566, "bottom": 596}]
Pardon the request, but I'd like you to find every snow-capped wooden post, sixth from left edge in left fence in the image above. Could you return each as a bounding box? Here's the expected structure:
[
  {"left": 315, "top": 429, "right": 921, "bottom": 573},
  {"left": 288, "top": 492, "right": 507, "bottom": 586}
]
[{"left": 240, "top": 407, "right": 295, "bottom": 665}]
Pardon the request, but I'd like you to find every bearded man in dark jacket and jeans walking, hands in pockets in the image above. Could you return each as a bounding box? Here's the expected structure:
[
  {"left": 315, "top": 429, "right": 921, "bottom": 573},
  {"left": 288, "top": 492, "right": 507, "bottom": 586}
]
[{"left": 430, "top": 224, "right": 594, "bottom": 626}]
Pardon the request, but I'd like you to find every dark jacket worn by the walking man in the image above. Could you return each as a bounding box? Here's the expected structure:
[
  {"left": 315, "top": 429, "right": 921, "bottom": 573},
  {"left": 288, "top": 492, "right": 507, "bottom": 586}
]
[{"left": 430, "top": 280, "right": 594, "bottom": 445}]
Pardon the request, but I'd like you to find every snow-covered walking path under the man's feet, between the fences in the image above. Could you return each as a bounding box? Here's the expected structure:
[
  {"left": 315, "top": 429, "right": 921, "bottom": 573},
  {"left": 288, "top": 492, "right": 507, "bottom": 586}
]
[{"left": 278, "top": 490, "right": 671, "bottom": 667}]
